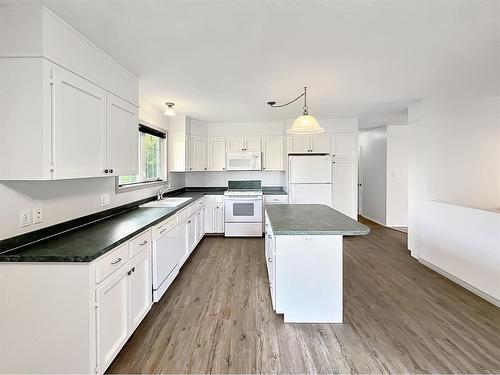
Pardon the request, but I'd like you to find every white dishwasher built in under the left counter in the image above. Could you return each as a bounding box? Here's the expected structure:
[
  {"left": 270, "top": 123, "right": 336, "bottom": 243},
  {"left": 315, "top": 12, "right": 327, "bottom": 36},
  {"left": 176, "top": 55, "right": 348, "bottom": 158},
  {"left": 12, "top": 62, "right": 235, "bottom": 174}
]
[{"left": 153, "top": 215, "right": 186, "bottom": 302}]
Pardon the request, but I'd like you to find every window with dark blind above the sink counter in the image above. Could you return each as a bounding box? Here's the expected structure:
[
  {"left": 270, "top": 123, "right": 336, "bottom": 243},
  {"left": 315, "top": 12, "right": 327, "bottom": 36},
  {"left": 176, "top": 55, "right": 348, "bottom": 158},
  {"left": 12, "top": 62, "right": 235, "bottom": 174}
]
[{"left": 118, "top": 125, "right": 167, "bottom": 188}]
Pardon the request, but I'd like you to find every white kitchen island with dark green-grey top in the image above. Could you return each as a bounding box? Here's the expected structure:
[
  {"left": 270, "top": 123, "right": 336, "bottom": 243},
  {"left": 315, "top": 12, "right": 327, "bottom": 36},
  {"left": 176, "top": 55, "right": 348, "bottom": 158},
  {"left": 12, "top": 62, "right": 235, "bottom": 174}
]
[{"left": 265, "top": 204, "right": 370, "bottom": 323}]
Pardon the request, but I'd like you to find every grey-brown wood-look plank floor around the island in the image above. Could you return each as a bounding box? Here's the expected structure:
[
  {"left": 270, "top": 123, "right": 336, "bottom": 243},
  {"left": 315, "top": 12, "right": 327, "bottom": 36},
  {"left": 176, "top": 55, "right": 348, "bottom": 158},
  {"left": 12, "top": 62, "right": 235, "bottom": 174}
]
[{"left": 108, "top": 223, "right": 500, "bottom": 373}]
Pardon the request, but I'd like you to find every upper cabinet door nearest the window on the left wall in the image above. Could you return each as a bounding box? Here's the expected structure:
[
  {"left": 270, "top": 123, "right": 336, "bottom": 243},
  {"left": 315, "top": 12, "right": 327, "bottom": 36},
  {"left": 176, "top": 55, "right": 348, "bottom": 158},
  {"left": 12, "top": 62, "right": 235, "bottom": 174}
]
[{"left": 105, "top": 94, "right": 139, "bottom": 176}]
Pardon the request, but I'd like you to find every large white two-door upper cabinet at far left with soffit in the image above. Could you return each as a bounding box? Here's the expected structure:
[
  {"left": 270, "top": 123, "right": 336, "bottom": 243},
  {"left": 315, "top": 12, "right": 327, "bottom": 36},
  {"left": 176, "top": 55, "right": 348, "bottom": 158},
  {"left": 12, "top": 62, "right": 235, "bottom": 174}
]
[{"left": 0, "top": 7, "right": 138, "bottom": 180}]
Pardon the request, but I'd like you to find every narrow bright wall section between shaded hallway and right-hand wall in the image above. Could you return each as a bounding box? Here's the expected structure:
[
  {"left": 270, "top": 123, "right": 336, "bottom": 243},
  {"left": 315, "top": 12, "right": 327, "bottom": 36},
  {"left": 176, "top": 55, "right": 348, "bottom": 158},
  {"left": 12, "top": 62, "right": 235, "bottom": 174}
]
[{"left": 386, "top": 126, "right": 410, "bottom": 227}]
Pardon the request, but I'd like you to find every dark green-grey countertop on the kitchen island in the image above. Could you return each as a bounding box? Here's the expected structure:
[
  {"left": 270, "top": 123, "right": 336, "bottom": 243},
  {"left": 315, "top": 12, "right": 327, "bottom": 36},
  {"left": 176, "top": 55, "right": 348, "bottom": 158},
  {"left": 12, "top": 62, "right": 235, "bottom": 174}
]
[{"left": 266, "top": 204, "right": 370, "bottom": 236}]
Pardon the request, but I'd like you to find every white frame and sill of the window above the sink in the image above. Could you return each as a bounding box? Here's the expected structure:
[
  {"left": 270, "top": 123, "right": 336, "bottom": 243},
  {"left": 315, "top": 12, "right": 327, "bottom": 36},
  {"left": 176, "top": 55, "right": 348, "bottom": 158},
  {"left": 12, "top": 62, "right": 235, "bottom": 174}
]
[{"left": 115, "top": 121, "right": 168, "bottom": 193}]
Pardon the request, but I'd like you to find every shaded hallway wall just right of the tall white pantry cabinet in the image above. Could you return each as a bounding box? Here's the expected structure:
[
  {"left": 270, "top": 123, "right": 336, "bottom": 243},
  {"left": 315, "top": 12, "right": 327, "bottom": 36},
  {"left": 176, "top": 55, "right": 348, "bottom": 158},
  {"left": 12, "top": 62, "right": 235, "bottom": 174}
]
[{"left": 359, "top": 127, "right": 387, "bottom": 225}]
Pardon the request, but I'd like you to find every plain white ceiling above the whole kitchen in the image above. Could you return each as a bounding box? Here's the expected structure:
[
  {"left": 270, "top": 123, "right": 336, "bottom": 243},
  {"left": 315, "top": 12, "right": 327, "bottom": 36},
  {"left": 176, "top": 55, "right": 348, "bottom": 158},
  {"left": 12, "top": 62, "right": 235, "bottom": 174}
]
[{"left": 24, "top": 0, "right": 500, "bottom": 127}]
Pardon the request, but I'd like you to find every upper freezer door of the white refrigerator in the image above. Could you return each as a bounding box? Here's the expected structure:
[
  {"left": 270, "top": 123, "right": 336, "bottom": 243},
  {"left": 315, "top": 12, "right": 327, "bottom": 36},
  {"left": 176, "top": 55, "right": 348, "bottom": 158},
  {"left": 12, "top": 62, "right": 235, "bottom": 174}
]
[{"left": 289, "top": 155, "right": 332, "bottom": 184}]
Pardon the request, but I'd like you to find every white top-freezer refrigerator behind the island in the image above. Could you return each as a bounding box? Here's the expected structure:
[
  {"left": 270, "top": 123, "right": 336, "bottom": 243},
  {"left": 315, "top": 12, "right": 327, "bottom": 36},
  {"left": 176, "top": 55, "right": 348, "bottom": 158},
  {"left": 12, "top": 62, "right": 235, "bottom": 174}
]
[{"left": 288, "top": 155, "right": 333, "bottom": 207}]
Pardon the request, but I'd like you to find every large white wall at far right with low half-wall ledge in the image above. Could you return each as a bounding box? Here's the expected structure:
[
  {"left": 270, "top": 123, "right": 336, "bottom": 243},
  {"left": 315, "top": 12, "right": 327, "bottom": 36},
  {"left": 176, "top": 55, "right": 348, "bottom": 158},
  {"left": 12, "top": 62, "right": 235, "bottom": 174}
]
[{"left": 408, "top": 96, "right": 500, "bottom": 303}]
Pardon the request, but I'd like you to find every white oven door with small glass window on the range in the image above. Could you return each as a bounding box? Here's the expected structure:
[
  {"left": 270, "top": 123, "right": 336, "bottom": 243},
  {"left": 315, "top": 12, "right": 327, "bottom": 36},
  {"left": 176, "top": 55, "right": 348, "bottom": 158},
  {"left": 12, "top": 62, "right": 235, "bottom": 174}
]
[{"left": 224, "top": 196, "right": 262, "bottom": 223}]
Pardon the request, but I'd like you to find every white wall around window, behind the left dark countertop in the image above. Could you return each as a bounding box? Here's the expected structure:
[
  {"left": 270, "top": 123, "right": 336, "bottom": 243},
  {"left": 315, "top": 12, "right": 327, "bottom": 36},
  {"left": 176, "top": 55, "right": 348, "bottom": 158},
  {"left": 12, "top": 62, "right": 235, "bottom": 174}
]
[{"left": 0, "top": 99, "right": 185, "bottom": 239}]
